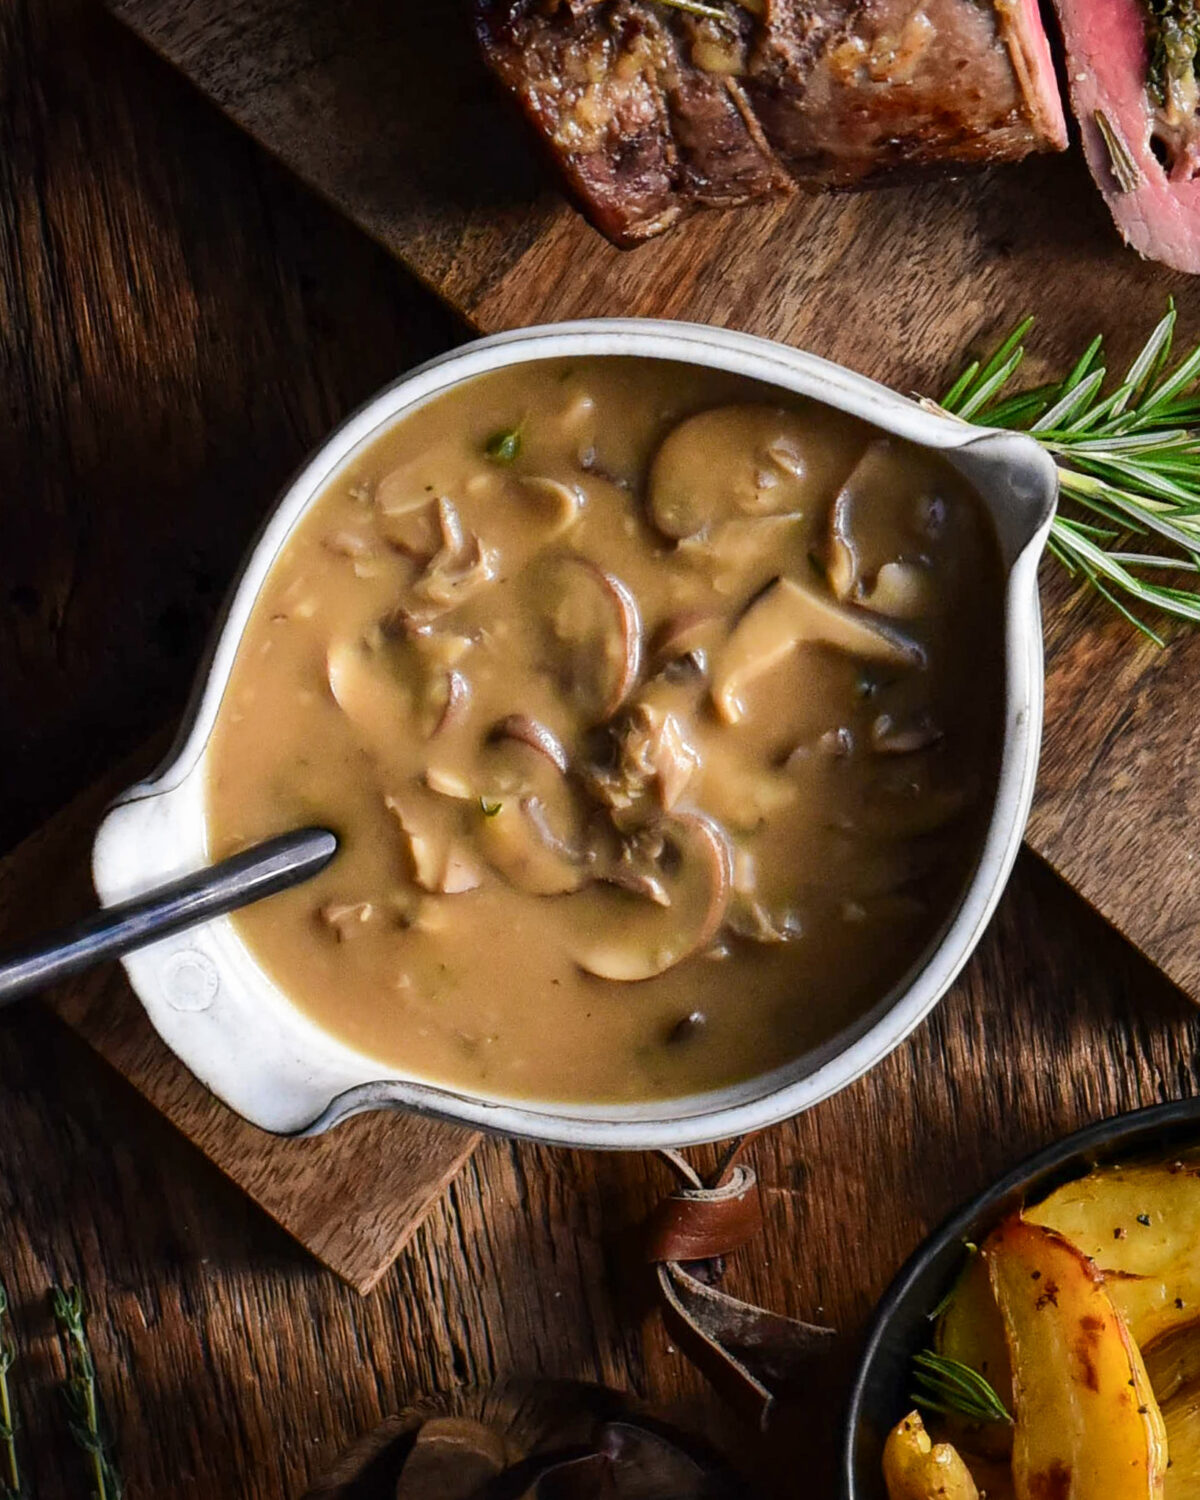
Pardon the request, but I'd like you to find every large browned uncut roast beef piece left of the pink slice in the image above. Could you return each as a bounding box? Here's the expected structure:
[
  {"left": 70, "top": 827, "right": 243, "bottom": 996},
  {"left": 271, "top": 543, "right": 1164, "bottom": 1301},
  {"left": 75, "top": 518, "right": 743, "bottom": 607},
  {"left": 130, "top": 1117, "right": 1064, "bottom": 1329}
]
[{"left": 474, "top": 0, "right": 1067, "bottom": 245}]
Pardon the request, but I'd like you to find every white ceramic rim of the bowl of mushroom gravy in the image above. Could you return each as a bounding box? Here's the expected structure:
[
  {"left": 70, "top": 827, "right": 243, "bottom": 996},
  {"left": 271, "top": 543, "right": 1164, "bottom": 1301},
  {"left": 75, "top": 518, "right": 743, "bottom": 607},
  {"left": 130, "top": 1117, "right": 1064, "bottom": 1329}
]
[{"left": 93, "top": 318, "right": 1056, "bottom": 1149}]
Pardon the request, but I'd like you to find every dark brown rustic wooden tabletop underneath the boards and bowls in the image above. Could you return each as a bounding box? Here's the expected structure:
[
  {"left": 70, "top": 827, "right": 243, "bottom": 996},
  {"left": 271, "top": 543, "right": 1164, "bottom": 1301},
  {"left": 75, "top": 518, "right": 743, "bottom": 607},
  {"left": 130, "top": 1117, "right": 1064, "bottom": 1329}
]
[{"left": 0, "top": 0, "right": 1200, "bottom": 1500}]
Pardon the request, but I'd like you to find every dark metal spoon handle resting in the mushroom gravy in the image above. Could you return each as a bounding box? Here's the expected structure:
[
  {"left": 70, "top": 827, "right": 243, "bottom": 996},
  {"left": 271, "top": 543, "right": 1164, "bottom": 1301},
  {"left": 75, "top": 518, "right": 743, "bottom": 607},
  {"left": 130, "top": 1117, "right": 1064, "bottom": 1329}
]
[{"left": 0, "top": 828, "right": 338, "bottom": 1005}]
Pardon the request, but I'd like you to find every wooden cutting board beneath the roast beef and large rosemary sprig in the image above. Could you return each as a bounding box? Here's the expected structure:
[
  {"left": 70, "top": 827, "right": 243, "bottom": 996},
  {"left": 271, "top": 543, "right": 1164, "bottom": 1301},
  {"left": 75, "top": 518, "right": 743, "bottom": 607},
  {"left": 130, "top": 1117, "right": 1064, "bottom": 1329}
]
[{"left": 110, "top": 0, "right": 1200, "bottom": 1020}]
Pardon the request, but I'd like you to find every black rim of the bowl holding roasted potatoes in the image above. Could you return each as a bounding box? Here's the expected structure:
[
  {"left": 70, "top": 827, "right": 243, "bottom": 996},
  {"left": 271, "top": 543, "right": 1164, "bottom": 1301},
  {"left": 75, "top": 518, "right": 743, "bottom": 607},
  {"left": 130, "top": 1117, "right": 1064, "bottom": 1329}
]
[{"left": 840, "top": 1097, "right": 1200, "bottom": 1500}]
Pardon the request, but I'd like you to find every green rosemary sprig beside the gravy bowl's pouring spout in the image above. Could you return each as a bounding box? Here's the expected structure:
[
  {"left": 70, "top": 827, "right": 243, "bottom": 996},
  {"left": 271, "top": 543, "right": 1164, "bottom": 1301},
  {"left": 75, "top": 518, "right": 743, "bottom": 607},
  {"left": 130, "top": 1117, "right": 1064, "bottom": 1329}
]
[{"left": 939, "top": 302, "right": 1200, "bottom": 645}]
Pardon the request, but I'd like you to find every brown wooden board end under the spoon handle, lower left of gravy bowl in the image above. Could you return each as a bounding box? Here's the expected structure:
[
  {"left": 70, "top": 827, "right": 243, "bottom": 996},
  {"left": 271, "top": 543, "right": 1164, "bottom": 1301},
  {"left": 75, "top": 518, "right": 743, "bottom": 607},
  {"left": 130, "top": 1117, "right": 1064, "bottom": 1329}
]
[{"left": 0, "top": 747, "right": 479, "bottom": 1293}]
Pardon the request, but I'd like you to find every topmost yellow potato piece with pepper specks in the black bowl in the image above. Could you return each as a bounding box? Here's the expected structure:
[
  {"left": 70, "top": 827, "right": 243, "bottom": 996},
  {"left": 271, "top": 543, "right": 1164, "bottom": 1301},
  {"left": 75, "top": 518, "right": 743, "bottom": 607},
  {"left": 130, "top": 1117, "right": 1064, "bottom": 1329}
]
[{"left": 1025, "top": 1151, "right": 1200, "bottom": 1349}]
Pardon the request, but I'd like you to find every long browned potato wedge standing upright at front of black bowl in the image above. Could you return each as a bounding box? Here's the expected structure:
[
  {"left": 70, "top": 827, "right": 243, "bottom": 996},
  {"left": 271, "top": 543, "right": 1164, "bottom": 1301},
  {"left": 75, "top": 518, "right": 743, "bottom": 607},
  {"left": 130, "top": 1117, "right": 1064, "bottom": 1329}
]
[{"left": 983, "top": 1215, "right": 1167, "bottom": 1500}]
